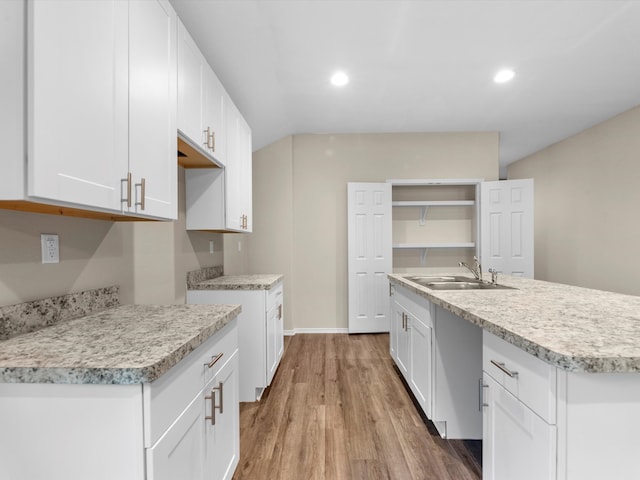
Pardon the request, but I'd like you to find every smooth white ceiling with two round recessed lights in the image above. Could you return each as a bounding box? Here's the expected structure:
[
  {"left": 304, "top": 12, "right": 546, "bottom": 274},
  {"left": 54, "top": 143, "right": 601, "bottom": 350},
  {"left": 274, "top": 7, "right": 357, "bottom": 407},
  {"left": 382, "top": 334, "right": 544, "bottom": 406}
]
[{"left": 172, "top": 0, "right": 640, "bottom": 169}]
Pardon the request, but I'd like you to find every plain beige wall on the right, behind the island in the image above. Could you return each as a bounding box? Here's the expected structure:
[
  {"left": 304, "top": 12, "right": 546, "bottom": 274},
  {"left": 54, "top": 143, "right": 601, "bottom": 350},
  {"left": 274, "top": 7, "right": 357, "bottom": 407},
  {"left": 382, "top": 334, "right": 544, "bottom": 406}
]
[{"left": 508, "top": 107, "right": 640, "bottom": 295}]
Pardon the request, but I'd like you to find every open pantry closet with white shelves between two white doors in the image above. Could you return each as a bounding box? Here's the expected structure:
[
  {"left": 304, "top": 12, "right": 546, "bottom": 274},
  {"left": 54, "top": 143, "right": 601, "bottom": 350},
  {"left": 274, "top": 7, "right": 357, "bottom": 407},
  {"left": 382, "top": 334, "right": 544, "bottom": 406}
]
[{"left": 387, "top": 179, "right": 482, "bottom": 271}]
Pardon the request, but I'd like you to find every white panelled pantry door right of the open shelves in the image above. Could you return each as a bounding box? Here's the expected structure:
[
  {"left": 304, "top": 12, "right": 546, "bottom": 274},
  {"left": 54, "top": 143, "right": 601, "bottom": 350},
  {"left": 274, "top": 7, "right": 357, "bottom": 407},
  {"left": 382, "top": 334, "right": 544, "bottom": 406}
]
[{"left": 480, "top": 178, "right": 533, "bottom": 278}]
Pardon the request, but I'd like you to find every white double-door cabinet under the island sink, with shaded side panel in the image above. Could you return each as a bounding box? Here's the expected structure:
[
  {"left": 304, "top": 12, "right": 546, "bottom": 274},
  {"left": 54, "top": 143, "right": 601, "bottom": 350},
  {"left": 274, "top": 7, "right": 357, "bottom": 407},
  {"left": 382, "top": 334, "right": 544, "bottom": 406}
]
[{"left": 390, "top": 285, "right": 482, "bottom": 439}]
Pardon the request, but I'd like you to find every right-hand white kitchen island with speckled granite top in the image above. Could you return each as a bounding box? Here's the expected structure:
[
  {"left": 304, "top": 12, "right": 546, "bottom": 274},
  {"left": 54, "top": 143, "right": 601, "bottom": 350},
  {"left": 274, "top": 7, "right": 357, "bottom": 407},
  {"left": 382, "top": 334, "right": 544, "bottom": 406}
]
[{"left": 389, "top": 274, "right": 640, "bottom": 480}]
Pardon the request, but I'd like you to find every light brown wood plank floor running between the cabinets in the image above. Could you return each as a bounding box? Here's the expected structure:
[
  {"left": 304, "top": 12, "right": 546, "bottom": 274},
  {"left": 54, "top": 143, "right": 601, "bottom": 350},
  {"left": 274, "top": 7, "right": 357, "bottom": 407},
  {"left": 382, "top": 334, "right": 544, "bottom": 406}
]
[{"left": 233, "top": 334, "right": 482, "bottom": 480}]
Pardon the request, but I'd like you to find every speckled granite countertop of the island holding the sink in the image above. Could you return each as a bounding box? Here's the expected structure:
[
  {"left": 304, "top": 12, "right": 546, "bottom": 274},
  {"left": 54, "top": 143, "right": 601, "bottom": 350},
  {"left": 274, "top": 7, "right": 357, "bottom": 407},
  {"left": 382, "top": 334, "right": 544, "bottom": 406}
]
[{"left": 389, "top": 274, "right": 640, "bottom": 373}]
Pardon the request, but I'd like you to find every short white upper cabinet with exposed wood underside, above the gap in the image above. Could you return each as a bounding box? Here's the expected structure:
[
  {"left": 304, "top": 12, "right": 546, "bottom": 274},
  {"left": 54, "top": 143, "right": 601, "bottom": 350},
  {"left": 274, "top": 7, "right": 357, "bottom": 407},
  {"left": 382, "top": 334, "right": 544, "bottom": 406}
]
[{"left": 178, "top": 22, "right": 226, "bottom": 167}]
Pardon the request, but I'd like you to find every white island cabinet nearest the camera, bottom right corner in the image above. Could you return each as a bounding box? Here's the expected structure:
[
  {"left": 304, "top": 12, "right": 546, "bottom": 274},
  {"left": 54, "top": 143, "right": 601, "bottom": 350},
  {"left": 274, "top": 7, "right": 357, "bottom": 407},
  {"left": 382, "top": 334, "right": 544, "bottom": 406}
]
[{"left": 481, "top": 331, "right": 640, "bottom": 480}]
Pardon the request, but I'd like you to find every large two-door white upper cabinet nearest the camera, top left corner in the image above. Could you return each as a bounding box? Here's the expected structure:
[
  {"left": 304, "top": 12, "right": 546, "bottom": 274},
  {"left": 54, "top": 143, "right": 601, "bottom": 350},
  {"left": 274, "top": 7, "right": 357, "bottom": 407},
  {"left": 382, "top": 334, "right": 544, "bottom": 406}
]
[{"left": 0, "top": 0, "right": 177, "bottom": 219}]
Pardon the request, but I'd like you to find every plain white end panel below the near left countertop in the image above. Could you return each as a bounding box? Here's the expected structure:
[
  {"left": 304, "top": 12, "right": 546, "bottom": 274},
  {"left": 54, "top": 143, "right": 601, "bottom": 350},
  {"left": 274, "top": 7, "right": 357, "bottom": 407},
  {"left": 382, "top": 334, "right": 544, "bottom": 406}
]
[{"left": 0, "top": 383, "right": 145, "bottom": 480}]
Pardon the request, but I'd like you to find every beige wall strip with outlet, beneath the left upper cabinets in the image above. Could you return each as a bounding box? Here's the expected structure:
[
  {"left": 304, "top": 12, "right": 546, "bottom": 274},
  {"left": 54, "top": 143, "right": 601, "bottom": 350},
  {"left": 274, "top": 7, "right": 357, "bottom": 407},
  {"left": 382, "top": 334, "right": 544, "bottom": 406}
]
[{"left": 0, "top": 169, "right": 224, "bottom": 305}]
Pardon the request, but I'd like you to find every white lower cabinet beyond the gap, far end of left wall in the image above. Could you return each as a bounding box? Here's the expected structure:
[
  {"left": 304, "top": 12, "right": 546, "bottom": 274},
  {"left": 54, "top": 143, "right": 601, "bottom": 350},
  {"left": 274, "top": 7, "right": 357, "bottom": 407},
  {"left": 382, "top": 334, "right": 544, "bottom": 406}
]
[{"left": 187, "top": 281, "right": 284, "bottom": 402}]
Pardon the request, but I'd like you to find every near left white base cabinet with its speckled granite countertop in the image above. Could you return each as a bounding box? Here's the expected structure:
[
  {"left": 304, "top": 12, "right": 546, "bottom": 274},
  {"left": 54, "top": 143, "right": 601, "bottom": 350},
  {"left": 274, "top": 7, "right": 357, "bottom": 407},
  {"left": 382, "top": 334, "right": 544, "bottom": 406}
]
[{"left": 0, "top": 305, "right": 241, "bottom": 480}]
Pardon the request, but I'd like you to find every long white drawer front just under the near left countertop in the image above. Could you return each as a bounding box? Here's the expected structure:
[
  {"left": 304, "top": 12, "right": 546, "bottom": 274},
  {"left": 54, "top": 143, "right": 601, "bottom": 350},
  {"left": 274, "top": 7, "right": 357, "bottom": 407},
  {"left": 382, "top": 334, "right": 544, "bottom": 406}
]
[{"left": 143, "top": 319, "right": 238, "bottom": 447}]
